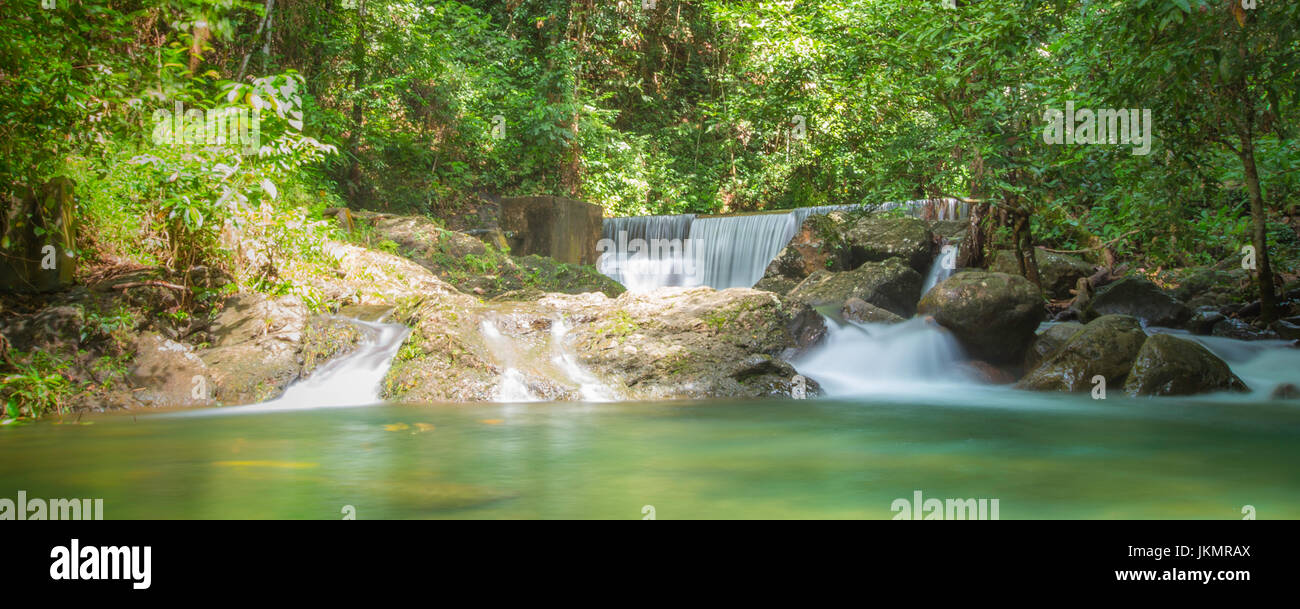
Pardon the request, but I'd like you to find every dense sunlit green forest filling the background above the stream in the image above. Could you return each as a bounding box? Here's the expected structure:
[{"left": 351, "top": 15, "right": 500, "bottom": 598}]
[{"left": 0, "top": 0, "right": 1300, "bottom": 416}]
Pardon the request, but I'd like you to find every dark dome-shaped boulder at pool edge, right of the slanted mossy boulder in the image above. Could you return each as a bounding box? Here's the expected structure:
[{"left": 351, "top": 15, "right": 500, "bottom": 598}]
[{"left": 1125, "top": 334, "right": 1249, "bottom": 396}]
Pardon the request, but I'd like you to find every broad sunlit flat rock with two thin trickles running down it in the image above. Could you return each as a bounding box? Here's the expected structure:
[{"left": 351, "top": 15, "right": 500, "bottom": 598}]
[{"left": 385, "top": 288, "right": 816, "bottom": 402}]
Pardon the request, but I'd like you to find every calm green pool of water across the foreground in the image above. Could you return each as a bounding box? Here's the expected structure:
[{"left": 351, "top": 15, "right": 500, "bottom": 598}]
[{"left": 0, "top": 389, "right": 1300, "bottom": 519}]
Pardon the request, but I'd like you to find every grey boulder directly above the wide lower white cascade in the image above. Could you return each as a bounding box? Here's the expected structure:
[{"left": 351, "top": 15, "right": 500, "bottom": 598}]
[{"left": 788, "top": 258, "right": 924, "bottom": 318}]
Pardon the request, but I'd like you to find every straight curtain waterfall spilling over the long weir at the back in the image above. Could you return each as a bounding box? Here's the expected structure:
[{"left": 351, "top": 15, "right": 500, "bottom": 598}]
[{"left": 597, "top": 199, "right": 967, "bottom": 291}]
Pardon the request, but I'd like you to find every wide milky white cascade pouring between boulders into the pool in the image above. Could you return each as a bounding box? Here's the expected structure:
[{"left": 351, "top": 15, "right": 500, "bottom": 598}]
[{"left": 790, "top": 318, "right": 970, "bottom": 397}]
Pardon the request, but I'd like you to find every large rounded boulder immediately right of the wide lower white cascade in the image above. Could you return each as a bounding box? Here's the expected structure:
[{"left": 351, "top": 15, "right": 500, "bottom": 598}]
[{"left": 918, "top": 271, "right": 1045, "bottom": 364}]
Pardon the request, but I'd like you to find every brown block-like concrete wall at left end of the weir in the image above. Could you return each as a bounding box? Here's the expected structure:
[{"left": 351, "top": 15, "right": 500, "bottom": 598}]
[{"left": 501, "top": 195, "right": 605, "bottom": 264}]
